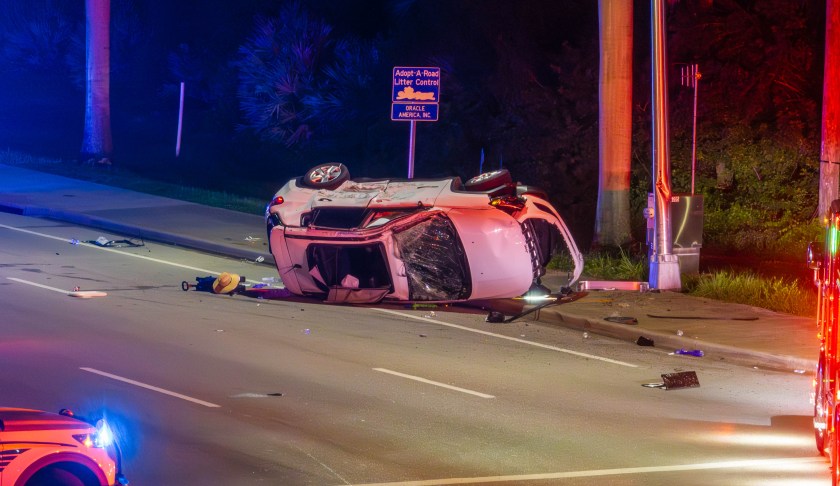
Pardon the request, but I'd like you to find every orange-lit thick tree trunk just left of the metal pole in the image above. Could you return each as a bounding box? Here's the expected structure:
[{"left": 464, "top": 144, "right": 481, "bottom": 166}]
[{"left": 593, "top": 0, "right": 633, "bottom": 246}]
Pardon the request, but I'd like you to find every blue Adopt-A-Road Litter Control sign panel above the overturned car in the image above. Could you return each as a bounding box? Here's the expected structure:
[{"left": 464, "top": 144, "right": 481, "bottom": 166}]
[{"left": 391, "top": 67, "right": 440, "bottom": 121}]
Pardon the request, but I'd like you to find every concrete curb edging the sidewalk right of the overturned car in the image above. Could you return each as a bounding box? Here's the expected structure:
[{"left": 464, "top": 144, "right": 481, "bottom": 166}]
[{"left": 540, "top": 308, "right": 817, "bottom": 374}]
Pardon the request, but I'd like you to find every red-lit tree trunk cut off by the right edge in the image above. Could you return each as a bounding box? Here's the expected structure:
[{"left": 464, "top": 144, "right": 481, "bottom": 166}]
[{"left": 817, "top": 0, "right": 840, "bottom": 218}]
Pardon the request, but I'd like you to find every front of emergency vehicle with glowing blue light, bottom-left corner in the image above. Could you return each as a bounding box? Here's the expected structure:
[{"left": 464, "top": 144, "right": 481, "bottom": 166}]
[{"left": 0, "top": 408, "right": 128, "bottom": 486}]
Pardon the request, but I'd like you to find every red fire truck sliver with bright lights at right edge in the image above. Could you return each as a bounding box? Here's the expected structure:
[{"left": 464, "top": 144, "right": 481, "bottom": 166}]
[{"left": 807, "top": 199, "right": 840, "bottom": 486}]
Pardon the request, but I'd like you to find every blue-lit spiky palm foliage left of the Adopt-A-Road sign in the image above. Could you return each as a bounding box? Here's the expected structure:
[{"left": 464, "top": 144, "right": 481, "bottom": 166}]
[{"left": 236, "top": 2, "right": 381, "bottom": 147}]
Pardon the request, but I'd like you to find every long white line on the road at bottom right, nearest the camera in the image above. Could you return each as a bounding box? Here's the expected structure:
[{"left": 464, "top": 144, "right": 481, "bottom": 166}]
[{"left": 342, "top": 457, "right": 825, "bottom": 486}]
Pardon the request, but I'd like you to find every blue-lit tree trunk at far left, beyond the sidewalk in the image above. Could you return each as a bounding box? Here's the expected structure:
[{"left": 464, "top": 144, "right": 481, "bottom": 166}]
[{"left": 81, "top": 0, "right": 113, "bottom": 164}]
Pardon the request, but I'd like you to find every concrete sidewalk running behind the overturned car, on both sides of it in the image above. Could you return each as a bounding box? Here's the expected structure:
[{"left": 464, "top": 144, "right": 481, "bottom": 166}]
[{"left": 0, "top": 165, "right": 818, "bottom": 373}]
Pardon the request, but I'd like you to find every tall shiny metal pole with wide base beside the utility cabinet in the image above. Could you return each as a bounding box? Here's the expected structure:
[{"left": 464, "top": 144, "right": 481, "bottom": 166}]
[{"left": 648, "top": 0, "right": 682, "bottom": 290}]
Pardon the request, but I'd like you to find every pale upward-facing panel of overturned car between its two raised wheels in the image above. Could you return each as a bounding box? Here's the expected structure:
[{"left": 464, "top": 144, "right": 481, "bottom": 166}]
[{"left": 302, "top": 179, "right": 452, "bottom": 209}]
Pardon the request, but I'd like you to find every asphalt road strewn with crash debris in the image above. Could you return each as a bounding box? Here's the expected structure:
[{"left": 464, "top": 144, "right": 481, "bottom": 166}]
[{"left": 0, "top": 214, "right": 829, "bottom": 486}]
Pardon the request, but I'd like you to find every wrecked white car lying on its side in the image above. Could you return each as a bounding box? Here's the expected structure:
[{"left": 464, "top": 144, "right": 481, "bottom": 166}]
[{"left": 266, "top": 163, "right": 583, "bottom": 303}]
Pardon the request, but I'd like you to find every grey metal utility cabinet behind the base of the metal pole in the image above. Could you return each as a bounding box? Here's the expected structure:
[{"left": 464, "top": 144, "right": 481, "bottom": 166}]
[{"left": 645, "top": 193, "right": 703, "bottom": 274}]
